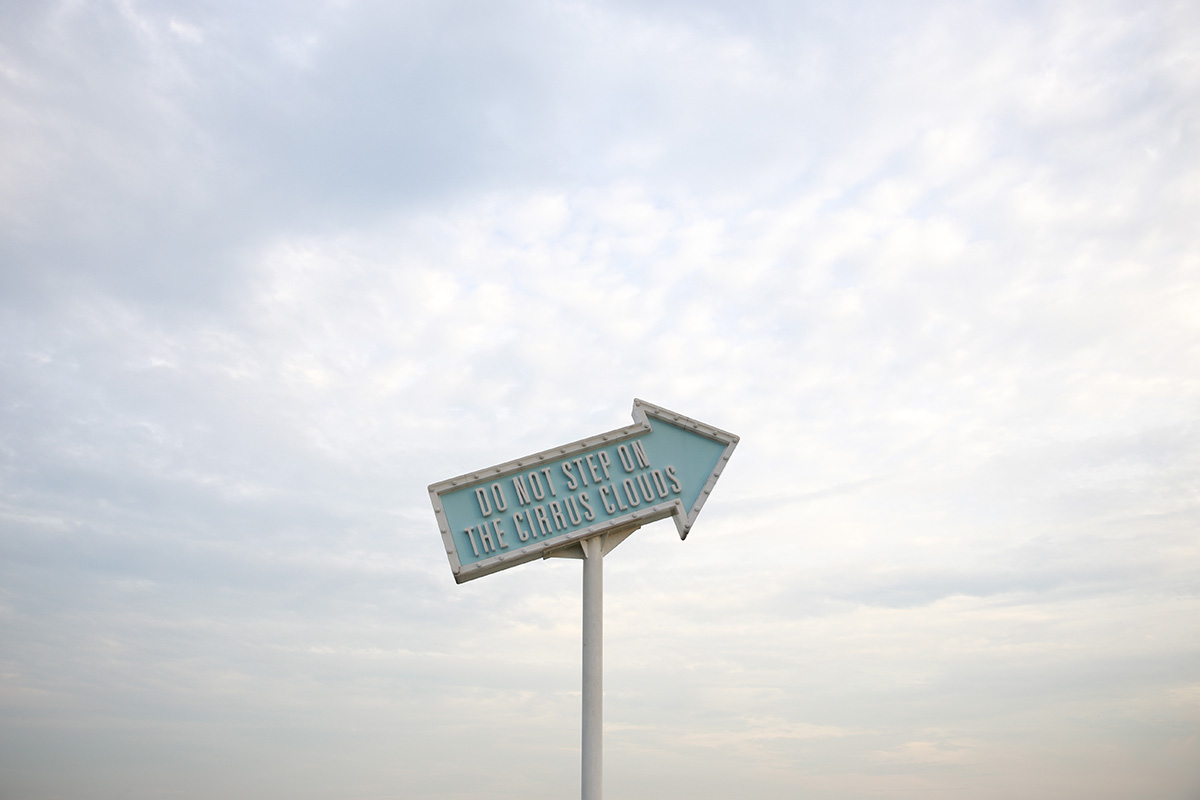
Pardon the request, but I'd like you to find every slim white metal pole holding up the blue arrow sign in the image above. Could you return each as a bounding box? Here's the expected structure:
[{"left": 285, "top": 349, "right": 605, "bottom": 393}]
[{"left": 581, "top": 536, "right": 604, "bottom": 800}]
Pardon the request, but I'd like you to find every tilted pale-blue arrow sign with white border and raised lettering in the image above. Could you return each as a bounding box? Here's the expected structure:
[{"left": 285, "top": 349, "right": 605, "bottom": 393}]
[{"left": 430, "top": 399, "right": 738, "bottom": 583}]
